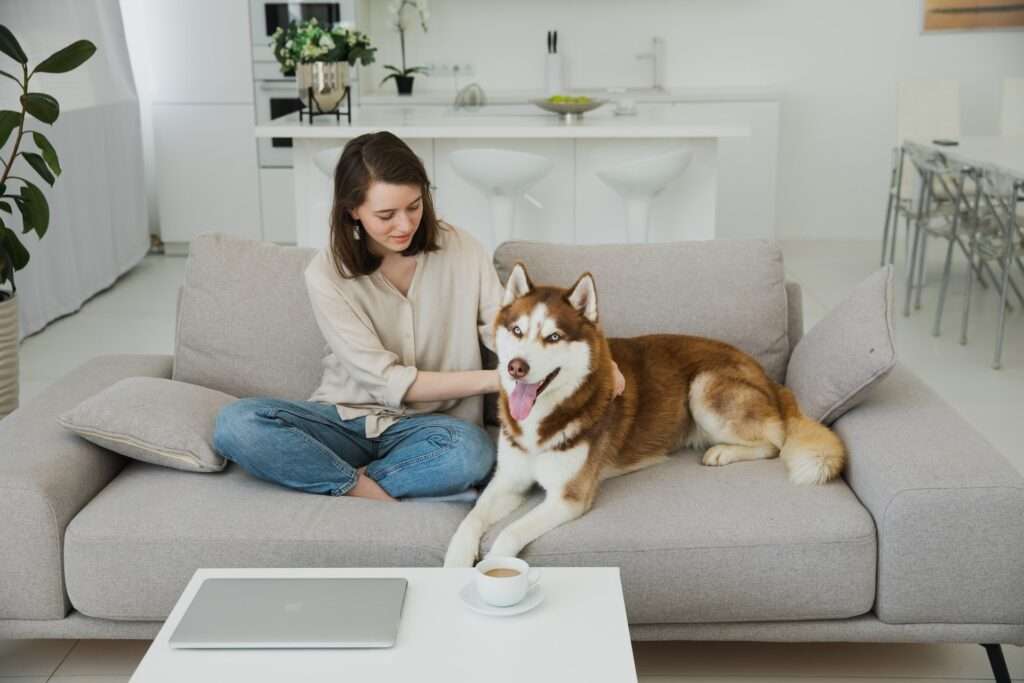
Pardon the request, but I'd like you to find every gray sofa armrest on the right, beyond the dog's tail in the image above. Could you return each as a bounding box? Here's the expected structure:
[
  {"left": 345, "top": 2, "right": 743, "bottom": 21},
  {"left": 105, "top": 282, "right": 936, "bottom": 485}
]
[{"left": 833, "top": 366, "right": 1024, "bottom": 624}]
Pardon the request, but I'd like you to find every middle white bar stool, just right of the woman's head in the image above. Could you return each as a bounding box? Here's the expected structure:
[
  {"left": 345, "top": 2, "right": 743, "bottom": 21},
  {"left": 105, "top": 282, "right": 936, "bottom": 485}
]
[{"left": 449, "top": 147, "right": 554, "bottom": 248}]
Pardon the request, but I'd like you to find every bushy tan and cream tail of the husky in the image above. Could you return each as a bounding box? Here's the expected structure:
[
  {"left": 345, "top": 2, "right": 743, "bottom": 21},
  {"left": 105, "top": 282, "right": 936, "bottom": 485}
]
[{"left": 775, "top": 384, "right": 846, "bottom": 484}]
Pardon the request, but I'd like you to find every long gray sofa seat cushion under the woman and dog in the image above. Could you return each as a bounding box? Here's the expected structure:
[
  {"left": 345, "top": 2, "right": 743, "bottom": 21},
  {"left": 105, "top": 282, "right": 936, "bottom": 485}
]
[{"left": 65, "top": 444, "right": 876, "bottom": 624}]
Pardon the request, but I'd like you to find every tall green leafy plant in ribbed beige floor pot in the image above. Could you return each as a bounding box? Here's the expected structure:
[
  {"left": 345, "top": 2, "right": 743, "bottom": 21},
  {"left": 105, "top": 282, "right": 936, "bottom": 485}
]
[{"left": 0, "top": 25, "right": 96, "bottom": 417}]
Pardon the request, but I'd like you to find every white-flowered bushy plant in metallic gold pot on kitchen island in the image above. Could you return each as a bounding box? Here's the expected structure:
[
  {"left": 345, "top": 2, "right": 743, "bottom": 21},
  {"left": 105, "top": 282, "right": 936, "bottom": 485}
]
[{"left": 270, "top": 16, "right": 377, "bottom": 112}]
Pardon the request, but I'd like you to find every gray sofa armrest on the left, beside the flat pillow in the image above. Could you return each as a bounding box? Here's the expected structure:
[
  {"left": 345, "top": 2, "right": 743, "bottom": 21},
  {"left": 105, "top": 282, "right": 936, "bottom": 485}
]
[{"left": 0, "top": 354, "right": 173, "bottom": 620}]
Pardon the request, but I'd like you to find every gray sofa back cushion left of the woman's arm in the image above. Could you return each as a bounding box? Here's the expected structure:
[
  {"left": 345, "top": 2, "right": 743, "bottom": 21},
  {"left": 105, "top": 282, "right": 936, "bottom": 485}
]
[{"left": 171, "top": 233, "right": 327, "bottom": 400}]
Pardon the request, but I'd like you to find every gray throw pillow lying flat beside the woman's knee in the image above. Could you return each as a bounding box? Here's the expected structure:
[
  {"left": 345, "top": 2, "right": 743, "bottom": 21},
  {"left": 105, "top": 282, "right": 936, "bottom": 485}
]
[{"left": 57, "top": 377, "right": 236, "bottom": 472}]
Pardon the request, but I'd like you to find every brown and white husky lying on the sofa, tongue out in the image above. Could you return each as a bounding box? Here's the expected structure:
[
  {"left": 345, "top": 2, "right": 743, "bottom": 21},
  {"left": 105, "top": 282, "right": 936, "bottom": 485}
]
[{"left": 444, "top": 263, "right": 846, "bottom": 566}]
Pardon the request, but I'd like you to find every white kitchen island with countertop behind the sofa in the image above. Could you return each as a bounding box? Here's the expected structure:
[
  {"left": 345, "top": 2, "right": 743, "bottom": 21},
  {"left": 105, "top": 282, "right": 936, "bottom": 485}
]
[{"left": 255, "top": 103, "right": 751, "bottom": 248}]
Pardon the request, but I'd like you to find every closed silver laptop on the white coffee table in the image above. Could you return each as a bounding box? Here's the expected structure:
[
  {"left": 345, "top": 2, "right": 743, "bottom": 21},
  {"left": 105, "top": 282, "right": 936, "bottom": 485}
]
[{"left": 168, "top": 578, "right": 409, "bottom": 648}]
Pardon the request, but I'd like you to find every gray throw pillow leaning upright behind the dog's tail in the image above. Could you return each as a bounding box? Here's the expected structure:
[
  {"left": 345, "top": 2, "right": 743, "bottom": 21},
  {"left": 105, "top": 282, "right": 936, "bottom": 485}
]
[{"left": 785, "top": 265, "right": 896, "bottom": 425}]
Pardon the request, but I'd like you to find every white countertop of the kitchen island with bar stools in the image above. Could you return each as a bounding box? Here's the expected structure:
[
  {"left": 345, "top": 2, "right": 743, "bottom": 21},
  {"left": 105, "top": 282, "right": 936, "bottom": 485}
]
[{"left": 256, "top": 103, "right": 751, "bottom": 139}]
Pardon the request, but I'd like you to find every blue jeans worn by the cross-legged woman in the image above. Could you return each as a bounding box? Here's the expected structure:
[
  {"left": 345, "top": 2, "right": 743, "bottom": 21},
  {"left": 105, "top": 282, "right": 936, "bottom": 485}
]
[{"left": 213, "top": 397, "right": 497, "bottom": 498}]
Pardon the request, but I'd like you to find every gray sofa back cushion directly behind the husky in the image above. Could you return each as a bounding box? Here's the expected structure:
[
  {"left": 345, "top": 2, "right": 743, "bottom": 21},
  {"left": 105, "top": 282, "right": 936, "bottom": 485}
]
[{"left": 495, "top": 240, "right": 790, "bottom": 383}]
